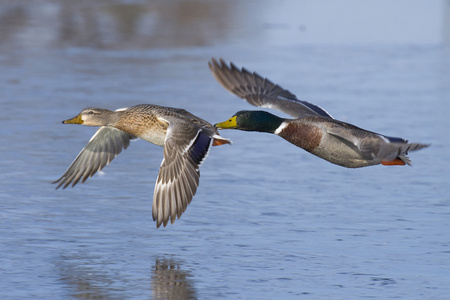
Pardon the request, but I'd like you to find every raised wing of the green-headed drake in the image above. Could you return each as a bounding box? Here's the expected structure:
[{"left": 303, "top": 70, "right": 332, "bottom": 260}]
[{"left": 208, "top": 58, "right": 333, "bottom": 118}]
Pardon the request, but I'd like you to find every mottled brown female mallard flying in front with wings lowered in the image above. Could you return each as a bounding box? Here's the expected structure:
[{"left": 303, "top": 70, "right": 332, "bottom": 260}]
[{"left": 54, "top": 104, "right": 230, "bottom": 227}]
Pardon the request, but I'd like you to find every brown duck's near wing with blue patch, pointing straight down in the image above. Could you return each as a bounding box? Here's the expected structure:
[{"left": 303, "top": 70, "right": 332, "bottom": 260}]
[{"left": 152, "top": 119, "right": 212, "bottom": 227}]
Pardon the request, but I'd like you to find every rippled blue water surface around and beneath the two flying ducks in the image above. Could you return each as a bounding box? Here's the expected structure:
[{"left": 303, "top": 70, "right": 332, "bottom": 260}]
[{"left": 0, "top": 2, "right": 450, "bottom": 299}]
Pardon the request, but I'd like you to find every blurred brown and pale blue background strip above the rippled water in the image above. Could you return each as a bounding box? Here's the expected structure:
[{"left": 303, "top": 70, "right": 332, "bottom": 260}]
[{"left": 0, "top": 0, "right": 450, "bottom": 49}]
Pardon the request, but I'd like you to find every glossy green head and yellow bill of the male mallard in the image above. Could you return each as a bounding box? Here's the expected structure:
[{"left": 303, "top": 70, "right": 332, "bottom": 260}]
[{"left": 214, "top": 110, "right": 284, "bottom": 133}]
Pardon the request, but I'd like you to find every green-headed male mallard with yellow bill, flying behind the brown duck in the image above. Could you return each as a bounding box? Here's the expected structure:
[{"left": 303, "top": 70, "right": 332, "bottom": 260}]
[{"left": 209, "top": 58, "right": 429, "bottom": 168}]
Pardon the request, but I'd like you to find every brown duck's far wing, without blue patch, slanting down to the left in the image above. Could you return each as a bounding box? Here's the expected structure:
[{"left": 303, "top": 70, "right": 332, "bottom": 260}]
[{"left": 53, "top": 126, "right": 136, "bottom": 189}]
